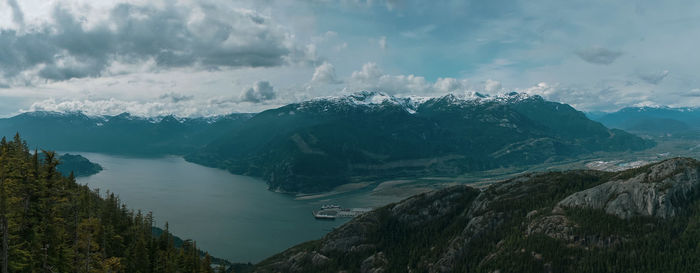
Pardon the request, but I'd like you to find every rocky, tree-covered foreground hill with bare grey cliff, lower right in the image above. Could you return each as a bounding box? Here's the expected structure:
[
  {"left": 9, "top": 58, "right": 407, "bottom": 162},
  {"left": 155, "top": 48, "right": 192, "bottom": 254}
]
[{"left": 255, "top": 158, "right": 700, "bottom": 272}]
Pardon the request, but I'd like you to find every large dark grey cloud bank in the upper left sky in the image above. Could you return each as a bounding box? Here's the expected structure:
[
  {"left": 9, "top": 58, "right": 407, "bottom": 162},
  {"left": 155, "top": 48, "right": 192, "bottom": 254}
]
[{"left": 0, "top": 0, "right": 294, "bottom": 80}]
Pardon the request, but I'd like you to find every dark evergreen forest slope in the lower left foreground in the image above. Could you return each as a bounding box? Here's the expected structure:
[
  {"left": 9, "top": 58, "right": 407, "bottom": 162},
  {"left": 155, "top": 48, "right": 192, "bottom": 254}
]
[{"left": 0, "top": 136, "right": 223, "bottom": 273}]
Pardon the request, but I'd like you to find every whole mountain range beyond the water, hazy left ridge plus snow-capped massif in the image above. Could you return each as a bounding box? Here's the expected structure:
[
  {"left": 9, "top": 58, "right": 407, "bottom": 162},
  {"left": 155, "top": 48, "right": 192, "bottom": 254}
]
[{"left": 0, "top": 91, "right": 654, "bottom": 193}]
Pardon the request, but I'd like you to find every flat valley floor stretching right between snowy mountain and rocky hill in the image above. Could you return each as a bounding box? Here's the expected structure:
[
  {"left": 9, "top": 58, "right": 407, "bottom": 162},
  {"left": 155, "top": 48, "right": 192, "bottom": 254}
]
[{"left": 296, "top": 137, "right": 700, "bottom": 207}]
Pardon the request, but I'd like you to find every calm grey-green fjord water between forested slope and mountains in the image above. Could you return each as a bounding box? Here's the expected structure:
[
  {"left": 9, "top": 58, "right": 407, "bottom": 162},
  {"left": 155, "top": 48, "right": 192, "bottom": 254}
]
[{"left": 78, "top": 152, "right": 357, "bottom": 262}]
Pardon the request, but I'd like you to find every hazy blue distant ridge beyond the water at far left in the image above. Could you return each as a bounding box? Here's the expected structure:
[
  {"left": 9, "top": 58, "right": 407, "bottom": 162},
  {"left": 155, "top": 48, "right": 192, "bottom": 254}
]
[{"left": 0, "top": 111, "right": 252, "bottom": 155}]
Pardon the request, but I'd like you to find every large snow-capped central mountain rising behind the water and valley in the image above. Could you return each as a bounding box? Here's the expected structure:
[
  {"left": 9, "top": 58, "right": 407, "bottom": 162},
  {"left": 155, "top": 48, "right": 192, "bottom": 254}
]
[{"left": 186, "top": 92, "right": 653, "bottom": 193}]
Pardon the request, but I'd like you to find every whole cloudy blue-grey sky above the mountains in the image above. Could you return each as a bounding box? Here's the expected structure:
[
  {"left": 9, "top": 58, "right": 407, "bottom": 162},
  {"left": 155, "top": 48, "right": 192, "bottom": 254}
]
[{"left": 0, "top": 0, "right": 700, "bottom": 117}]
